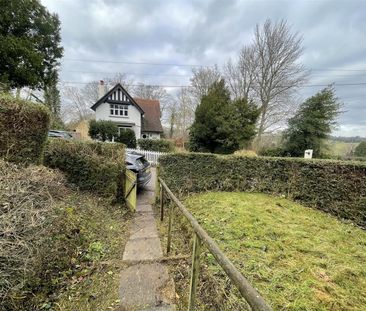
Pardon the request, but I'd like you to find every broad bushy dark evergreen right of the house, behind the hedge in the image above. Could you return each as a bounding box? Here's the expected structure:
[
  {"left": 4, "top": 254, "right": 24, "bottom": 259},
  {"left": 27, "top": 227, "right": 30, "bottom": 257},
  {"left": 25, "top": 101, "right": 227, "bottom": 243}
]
[{"left": 189, "top": 79, "right": 259, "bottom": 153}]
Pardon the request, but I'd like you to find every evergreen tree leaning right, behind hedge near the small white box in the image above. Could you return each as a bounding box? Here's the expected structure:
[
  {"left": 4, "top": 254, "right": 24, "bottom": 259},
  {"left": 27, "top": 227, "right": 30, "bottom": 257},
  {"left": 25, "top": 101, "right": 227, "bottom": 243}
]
[{"left": 284, "top": 87, "right": 341, "bottom": 157}]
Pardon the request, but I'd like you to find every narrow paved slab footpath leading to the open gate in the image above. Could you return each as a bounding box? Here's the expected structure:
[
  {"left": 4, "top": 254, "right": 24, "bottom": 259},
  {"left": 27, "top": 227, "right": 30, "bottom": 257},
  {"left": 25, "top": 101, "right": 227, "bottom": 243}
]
[{"left": 120, "top": 169, "right": 176, "bottom": 311}]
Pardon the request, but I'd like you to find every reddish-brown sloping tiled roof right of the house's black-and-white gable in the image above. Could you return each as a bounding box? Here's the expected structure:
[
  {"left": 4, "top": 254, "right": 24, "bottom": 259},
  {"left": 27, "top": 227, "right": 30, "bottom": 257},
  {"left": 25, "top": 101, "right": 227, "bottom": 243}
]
[{"left": 134, "top": 98, "right": 163, "bottom": 133}]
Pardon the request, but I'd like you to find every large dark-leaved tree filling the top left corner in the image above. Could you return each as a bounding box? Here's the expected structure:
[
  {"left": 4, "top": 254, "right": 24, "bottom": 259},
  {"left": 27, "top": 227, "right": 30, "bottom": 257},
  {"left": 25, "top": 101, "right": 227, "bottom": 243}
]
[{"left": 0, "top": 0, "right": 63, "bottom": 89}]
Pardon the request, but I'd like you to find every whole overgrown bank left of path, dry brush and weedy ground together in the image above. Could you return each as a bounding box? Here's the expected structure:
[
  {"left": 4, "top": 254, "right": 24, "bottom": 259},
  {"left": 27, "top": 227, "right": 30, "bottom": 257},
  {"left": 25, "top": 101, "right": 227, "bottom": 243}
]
[{"left": 0, "top": 159, "right": 130, "bottom": 311}]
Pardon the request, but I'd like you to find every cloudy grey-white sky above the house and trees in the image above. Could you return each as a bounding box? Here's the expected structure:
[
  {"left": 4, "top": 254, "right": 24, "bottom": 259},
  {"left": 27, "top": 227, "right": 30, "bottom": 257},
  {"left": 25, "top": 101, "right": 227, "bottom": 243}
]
[{"left": 42, "top": 0, "right": 366, "bottom": 137}]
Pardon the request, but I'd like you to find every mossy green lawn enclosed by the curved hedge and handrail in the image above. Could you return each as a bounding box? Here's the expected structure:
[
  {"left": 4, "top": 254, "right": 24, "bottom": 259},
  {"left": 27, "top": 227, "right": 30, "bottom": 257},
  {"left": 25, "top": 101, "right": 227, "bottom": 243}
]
[{"left": 185, "top": 192, "right": 366, "bottom": 310}]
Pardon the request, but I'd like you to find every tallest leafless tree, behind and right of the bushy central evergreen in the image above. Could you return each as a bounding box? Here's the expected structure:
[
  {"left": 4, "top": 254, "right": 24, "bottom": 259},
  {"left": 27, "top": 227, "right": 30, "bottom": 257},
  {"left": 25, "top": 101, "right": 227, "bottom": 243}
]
[{"left": 224, "top": 20, "right": 308, "bottom": 140}]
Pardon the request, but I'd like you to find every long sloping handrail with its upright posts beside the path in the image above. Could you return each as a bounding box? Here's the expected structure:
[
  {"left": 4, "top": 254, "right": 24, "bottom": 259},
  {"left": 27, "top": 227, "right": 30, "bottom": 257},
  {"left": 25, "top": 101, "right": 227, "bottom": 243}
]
[{"left": 158, "top": 177, "right": 272, "bottom": 311}]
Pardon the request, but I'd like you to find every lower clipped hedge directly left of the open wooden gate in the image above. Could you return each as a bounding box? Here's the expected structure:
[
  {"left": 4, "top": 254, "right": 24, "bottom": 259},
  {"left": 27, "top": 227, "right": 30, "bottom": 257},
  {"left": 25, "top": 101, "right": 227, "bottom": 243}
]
[{"left": 44, "top": 139, "right": 125, "bottom": 199}]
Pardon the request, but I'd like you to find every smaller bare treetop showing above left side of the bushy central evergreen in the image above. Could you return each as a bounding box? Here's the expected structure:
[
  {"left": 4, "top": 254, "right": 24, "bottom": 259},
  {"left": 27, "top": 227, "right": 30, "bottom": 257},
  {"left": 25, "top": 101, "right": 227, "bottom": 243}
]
[{"left": 191, "top": 65, "right": 222, "bottom": 105}]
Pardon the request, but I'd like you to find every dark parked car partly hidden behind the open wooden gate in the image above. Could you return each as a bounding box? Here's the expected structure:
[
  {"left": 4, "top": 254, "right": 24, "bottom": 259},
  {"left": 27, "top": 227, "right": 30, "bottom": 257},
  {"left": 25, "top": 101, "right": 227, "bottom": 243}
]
[{"left": 126, "top": 152, "right": 151, "bottom": 188}]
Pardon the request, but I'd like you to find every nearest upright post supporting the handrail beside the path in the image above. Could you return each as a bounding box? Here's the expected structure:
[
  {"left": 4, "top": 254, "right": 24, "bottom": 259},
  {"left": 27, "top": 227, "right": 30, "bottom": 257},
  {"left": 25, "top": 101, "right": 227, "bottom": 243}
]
[{"left": 188, "top": 233, "right": 202, "bottom": 311}]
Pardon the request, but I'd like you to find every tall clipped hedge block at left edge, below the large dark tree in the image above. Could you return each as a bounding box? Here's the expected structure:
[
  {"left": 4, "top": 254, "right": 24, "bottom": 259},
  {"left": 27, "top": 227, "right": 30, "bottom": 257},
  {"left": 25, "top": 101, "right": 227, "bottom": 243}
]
[{"left": 0, "top": 94, "right": 50, "bottom": 164}]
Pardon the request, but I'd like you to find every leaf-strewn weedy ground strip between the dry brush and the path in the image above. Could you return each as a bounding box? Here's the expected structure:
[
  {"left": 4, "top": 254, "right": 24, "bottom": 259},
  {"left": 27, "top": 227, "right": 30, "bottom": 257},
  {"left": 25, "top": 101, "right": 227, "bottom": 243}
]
[{"left": 51, "top": 193, "right": 131, "bottom": 311}]
